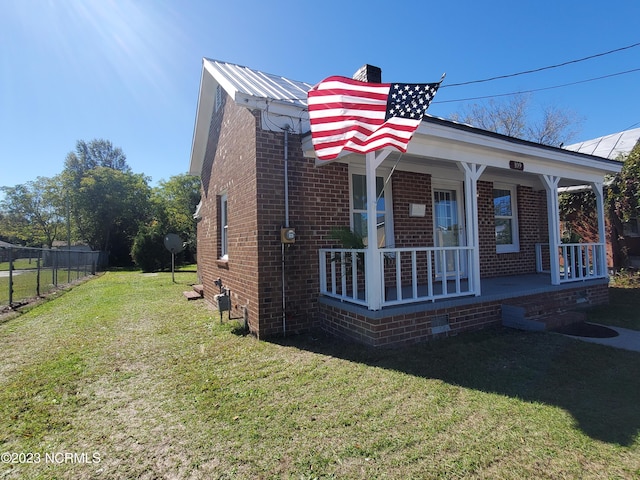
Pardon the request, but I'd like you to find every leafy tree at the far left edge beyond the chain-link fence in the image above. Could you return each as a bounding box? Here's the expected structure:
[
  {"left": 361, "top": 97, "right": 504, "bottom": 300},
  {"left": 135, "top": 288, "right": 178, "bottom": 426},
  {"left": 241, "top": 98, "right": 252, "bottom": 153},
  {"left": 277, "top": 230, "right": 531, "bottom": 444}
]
[{"left": 0, "top": 177, "right": 65, "bottom": 248}]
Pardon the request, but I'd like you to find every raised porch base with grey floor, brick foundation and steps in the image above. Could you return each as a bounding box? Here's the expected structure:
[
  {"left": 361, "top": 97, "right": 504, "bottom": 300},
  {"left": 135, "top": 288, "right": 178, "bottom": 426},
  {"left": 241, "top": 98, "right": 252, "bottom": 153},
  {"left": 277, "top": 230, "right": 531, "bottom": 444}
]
[{"left": 319, "top": 273, "right": 609, "bottom": 347}]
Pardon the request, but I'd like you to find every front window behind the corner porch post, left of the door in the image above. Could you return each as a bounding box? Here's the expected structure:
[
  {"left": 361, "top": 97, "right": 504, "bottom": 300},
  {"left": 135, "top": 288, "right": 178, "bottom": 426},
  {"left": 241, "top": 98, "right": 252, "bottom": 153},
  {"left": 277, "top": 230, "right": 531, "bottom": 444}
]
[{"left": 351, "top": 172, "right": 393, "bottom": 247}]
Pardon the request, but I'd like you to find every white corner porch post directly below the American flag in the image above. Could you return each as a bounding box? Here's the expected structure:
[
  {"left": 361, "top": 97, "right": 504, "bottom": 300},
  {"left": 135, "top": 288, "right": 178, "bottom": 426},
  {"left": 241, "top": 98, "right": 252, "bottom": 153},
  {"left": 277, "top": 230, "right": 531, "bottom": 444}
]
[{"left": 365, "top": 150, "right": 391, "bottom": 310}]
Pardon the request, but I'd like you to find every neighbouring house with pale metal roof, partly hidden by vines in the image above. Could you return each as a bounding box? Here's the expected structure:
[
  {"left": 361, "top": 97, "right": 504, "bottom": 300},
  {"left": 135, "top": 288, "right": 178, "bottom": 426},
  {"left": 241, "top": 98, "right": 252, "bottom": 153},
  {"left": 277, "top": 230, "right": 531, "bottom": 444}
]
[{"left": 565, "top": 128, "right": 640, "bottom": 268}]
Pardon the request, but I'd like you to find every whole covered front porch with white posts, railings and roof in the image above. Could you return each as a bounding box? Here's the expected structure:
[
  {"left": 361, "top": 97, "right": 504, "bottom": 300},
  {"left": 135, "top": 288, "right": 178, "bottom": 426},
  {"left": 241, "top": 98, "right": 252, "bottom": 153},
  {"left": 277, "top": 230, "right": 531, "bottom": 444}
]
[{"left": 310, "top": 117, "right": 621, "bottom": 345}]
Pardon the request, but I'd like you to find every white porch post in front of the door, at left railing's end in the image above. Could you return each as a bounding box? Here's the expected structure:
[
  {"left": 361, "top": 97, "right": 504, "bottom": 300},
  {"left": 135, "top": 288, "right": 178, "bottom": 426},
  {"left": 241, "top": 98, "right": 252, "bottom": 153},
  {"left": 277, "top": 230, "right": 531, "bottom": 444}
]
[{"left": 458, "top": 162, "right": 486, "bottom": 297}]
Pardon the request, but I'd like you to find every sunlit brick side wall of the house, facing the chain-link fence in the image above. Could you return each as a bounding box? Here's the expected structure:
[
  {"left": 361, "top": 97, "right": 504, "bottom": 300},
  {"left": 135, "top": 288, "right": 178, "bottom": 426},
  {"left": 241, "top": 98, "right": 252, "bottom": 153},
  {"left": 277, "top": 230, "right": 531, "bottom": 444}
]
[{"left": 198, "top": 87, "right": 259, "bottom": 331}]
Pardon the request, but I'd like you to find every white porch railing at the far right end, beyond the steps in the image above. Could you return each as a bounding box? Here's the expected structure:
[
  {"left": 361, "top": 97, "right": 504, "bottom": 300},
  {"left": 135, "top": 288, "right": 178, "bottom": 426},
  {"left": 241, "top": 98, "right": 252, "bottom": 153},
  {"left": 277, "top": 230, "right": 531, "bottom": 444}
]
[{"left": 536, "top": 243, "right": 607, "bottom": 283}]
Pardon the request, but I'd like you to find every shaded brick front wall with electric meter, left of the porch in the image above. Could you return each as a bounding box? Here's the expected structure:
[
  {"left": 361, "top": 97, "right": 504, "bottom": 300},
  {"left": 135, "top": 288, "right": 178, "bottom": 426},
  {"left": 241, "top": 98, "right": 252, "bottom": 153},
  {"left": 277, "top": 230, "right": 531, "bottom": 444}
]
[{"left": 258, "top": 131, "right": 349, "bottom": 336}]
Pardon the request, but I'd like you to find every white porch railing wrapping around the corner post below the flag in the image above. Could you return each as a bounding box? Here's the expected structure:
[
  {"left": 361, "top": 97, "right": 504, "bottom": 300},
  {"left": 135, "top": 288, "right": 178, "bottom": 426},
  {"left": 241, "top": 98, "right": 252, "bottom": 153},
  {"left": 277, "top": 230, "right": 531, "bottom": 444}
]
[{"left": 320, "top": 247, "right": 476, "bottom": 306}]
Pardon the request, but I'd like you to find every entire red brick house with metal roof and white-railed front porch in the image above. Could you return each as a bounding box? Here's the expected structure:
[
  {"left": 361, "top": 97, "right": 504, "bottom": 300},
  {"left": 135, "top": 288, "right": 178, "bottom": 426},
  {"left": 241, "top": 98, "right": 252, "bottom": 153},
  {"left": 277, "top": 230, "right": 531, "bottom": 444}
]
[{"left": 189, "top": 59, "right": 620, "bottom": 346}]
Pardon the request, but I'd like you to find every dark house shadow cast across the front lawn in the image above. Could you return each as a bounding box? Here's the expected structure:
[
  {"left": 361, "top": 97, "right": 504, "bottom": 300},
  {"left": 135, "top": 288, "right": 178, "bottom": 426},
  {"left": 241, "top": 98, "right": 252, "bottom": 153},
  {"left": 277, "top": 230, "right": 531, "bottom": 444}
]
[{"left": 274, "top": 329, "right": 640, "bottom": 446}]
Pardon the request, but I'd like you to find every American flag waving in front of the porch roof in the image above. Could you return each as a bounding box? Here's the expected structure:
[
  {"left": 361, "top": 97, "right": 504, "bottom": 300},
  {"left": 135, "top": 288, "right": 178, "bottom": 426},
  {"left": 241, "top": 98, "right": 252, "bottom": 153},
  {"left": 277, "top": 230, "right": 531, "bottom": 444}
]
[{"left": 308, "top": 76, "right": 440, "bottom": 160}]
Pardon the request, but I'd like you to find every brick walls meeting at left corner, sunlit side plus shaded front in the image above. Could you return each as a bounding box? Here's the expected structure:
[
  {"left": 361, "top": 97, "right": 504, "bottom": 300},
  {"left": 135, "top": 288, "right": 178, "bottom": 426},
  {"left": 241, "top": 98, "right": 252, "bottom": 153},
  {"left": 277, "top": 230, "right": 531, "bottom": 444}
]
[{"left": 198, "top": 94, "right": 349, "bottom": 337}]
